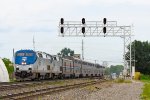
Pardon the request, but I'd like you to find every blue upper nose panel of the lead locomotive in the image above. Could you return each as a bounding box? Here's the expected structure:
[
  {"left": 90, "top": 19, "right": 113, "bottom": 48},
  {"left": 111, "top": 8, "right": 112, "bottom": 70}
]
[{"left": 15, "top": 50, "right": 37, "bottom": 65}]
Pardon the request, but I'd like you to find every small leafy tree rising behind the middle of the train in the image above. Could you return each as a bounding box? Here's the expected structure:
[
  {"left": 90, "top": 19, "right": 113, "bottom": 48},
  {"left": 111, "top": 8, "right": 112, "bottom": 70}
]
[{"left": 58, "top": 48, "right": 74, "bottom": 57}]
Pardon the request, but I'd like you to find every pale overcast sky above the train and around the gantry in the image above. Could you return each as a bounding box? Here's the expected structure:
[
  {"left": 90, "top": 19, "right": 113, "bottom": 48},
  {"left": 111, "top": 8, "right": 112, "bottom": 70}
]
[{"left": 0, "top": 0, "right": 150, "bottom": 64}]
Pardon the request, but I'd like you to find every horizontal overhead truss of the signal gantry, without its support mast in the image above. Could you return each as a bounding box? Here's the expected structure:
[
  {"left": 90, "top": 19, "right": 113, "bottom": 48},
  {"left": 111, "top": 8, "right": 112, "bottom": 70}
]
[{"left": 59, "top": 19, "right": 131, "bottom": 37}]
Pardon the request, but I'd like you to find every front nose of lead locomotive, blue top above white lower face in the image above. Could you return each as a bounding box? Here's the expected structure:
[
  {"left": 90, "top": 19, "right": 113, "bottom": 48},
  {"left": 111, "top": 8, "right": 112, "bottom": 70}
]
[{"left": 15, "top": 50, "right": 37, "bottom": 78}]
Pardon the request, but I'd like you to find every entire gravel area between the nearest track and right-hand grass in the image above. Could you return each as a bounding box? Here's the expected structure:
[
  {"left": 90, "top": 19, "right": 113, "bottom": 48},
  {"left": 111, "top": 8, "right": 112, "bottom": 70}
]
[{"left": 37, "top": 81, "right": 143, "bottom": 100}]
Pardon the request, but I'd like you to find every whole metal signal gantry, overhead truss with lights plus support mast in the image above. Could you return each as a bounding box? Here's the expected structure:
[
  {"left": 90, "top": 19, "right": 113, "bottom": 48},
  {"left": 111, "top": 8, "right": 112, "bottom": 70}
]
[{"left": 59, "top": 18, "right": 134, "bottom": 77}]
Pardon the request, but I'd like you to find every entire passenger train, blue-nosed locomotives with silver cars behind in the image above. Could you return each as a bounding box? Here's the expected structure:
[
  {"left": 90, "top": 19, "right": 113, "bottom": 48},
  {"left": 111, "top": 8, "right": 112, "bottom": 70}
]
[{"left": 14, "top": 50, "right": 105, "bottom": 80}]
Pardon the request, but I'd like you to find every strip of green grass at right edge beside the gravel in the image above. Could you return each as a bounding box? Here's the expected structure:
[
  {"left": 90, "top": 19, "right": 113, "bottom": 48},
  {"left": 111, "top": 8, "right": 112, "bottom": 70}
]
[{"left": 141, "top": 75, "right": 150, "bottom": 100}]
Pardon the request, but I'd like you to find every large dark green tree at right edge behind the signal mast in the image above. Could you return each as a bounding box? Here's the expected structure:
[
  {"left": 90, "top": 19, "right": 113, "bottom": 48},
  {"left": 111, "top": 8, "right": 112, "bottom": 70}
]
[{"left": 126, "top": 40, "right": 150, "bottom": 74}]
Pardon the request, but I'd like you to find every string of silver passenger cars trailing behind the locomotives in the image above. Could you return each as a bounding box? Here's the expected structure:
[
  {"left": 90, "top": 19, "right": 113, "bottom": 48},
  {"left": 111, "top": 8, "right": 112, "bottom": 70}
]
[{"left": 61, "top": 56, "right": 105, "bottom": 77}]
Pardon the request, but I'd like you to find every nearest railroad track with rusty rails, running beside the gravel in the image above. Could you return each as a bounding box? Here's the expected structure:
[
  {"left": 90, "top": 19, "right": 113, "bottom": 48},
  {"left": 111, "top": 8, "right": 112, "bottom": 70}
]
[{"left": 0, "top": 80, "right": 106, "bottom": 100}]
